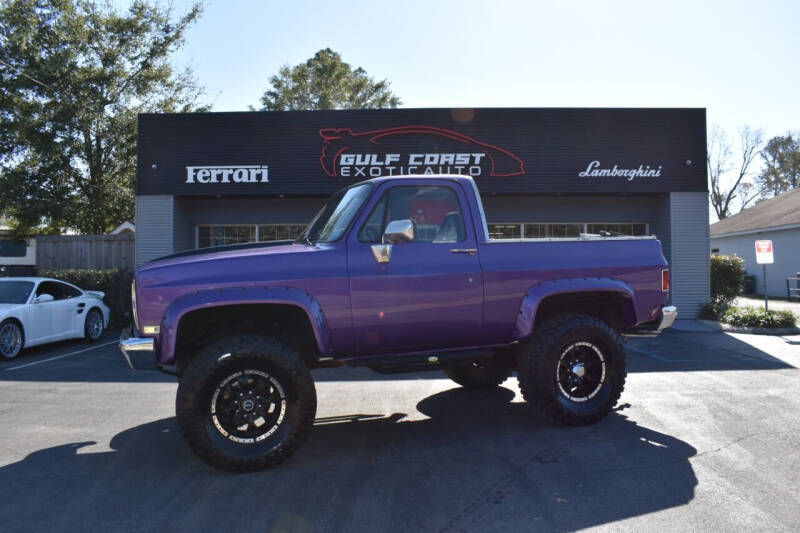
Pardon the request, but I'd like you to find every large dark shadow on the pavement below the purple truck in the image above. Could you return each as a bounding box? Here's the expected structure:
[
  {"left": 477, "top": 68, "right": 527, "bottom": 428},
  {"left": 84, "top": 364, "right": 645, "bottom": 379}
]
[{"left": 0, "top": 388, "right": 697, "bottom": 531}]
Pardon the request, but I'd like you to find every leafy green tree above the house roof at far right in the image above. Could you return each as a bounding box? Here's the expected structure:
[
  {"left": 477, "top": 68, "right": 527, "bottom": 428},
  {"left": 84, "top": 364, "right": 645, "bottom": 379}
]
[{"left": 757, "top": 133, "right": 800, "bottom": 198}]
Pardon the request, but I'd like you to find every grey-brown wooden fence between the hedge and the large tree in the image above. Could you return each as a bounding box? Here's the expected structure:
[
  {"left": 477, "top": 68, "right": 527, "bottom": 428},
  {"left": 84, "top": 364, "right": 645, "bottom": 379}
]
[{"left": 36, "top": 234, "right": 134, "bottom": 271}]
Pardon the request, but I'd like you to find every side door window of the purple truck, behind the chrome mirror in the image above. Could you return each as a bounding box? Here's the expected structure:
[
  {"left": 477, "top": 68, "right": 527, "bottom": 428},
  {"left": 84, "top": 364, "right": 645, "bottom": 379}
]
[{"left": 358, "top": 186, "right": 466, "bottom": 243}]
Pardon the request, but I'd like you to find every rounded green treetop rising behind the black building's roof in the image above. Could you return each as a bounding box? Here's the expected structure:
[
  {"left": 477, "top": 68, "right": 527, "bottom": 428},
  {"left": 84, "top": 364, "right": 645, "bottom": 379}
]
[{"left": 261, "top": 48, "right": 402, "bottom": 111}]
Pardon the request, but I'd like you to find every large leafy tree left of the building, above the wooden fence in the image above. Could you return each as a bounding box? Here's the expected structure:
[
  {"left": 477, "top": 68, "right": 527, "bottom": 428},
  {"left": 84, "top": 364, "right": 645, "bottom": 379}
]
[{"left": 0, "top": 0, "right": 202, "bottom": 236}]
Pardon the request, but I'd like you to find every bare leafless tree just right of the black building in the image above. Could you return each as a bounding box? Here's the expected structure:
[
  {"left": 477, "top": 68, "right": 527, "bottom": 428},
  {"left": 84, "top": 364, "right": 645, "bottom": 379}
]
[{"left": 706, "top": 125, "right": 764, "bottom": 220}]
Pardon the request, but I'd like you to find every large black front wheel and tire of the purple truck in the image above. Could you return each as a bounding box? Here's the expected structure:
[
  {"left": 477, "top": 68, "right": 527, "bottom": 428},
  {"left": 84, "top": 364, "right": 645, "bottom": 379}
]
[{"left": 176, "top": 335, "right": 317, "bottom": 472}]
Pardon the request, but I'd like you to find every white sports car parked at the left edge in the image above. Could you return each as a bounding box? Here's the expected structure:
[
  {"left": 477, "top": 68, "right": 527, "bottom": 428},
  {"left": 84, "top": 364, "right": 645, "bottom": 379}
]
[{"left": 0, "top": 278, "right": 110, "bottom": 359}]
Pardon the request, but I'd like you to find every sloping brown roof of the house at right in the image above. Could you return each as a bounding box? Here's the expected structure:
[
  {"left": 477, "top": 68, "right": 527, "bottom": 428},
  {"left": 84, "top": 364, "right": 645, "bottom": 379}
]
[{"left": 709, "top": 189, "right": 800, "bottom": 237}]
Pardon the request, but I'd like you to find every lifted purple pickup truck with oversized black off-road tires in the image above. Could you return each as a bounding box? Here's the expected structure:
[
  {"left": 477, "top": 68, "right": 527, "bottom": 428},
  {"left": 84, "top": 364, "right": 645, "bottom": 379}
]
[{"left": 120, "top": 176, "right": 677, "bottom": 471}]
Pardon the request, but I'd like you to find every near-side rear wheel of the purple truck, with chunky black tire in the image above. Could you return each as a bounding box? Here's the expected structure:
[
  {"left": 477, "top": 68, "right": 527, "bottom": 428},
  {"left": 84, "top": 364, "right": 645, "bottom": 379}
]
[{"left": 517, "top": 314, "right": 626, "bottom": 426}]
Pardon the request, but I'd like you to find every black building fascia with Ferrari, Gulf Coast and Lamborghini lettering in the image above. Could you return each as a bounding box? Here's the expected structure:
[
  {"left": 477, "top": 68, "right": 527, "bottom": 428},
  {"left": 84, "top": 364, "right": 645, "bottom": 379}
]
[{"left": 137, "top": 108, "right": 707, "bottom": 196}]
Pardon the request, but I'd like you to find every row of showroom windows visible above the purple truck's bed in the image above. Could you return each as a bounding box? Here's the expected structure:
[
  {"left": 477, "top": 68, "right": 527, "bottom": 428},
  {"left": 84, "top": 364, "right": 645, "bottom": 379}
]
[{"left": 488, "top": 222, "right": 650, "bottom": 239}]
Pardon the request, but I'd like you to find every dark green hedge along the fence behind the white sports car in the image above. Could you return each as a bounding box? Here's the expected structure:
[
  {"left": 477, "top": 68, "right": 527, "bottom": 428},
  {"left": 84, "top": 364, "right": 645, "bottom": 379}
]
[{"left": 39, "top": 268, "right": 132, "bottom": 327}]
